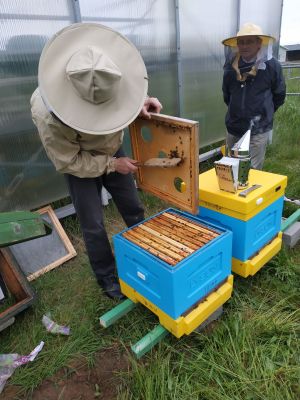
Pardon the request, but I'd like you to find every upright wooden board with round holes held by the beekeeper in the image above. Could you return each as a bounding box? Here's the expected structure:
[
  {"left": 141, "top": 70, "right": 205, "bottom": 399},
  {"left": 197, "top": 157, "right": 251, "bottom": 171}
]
[{"left": 129, "top": 114, "right": 199, "bottom": 214}]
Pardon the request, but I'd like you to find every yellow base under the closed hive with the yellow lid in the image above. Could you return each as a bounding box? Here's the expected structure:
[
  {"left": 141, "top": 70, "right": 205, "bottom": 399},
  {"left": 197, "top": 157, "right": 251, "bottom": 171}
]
[{"left": 232, "top": 232, "right": 282, "bottom": 278}]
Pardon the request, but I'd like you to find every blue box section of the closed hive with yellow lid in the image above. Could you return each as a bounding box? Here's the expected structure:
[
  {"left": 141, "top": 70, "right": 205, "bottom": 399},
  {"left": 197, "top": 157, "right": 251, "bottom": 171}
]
[{"left": 199, "top": 197, "right": 283, "bottom": 261}]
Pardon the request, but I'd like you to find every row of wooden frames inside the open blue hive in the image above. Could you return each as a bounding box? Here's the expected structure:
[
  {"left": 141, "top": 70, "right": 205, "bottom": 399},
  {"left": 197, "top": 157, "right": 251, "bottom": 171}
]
[{"left": 122, "top": 211, "right": 220, "bottom": 266}]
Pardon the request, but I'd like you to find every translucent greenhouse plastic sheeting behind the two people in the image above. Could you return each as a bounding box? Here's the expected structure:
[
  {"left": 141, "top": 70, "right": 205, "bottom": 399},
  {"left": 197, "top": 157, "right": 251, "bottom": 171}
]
[{"left": 0, "top": 0, "right": 282, "bottom": 212}]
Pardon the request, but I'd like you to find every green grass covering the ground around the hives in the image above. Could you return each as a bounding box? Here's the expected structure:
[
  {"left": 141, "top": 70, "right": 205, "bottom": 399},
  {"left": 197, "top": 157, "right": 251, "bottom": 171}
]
[{"left": 0, "top": 83, "right": 300, "bottom": 400}]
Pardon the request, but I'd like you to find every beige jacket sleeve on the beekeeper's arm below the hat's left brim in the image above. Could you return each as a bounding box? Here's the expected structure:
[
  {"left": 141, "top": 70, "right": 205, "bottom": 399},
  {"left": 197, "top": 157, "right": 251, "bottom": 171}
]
[{"left": 33, "top": 114, "right": 113, "bottom": 178}]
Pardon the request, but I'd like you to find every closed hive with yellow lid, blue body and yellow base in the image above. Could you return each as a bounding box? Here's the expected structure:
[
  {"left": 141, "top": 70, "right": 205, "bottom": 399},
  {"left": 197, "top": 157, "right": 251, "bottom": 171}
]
[{"left": 199, "top": 169, "right": 287, "bottom": 277}]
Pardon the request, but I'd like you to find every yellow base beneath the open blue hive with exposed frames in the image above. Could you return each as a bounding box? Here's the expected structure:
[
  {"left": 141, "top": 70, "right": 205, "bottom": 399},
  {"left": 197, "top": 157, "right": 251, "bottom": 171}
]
[{"left": 120, "top": 275, "right": 233, "bottom": 338}]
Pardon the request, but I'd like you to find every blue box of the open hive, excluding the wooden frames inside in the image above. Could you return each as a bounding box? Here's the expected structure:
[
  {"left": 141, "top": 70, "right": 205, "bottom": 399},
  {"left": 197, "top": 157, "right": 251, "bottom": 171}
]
[{"left": 113, "top": 208, "right": 232, "bottom": 319}]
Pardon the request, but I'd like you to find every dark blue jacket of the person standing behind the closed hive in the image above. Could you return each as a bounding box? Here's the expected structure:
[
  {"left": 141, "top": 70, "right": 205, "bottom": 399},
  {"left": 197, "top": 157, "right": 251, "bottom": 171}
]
[{"left": 222, "top": 58, "right": 286, "bottom": 136}]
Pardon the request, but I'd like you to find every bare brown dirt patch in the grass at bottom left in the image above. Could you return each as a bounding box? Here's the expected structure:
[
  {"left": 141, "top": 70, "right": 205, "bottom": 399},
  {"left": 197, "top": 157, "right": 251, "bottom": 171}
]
[{"left": 0, "top": 349, "right": 129, "bottom": 400}]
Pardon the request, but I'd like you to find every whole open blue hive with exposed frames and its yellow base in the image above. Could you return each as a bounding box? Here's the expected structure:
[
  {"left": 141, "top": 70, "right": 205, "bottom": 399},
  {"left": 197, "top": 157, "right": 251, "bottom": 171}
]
[{"left": 114, "top": 209, "right": 232, "bottom": 337}]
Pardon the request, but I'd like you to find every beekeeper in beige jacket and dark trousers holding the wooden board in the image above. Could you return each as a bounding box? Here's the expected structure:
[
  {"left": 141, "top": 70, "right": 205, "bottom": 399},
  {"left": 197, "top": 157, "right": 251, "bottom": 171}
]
[{"left": 31, "top": 23, "right": 162, "bottom": 299}]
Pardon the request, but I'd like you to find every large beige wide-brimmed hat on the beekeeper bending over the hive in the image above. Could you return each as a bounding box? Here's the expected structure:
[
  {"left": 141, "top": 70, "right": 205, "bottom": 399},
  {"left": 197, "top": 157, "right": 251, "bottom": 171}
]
[{"left": 38, "top": 23, "right": 148, "bottom": 135}]
